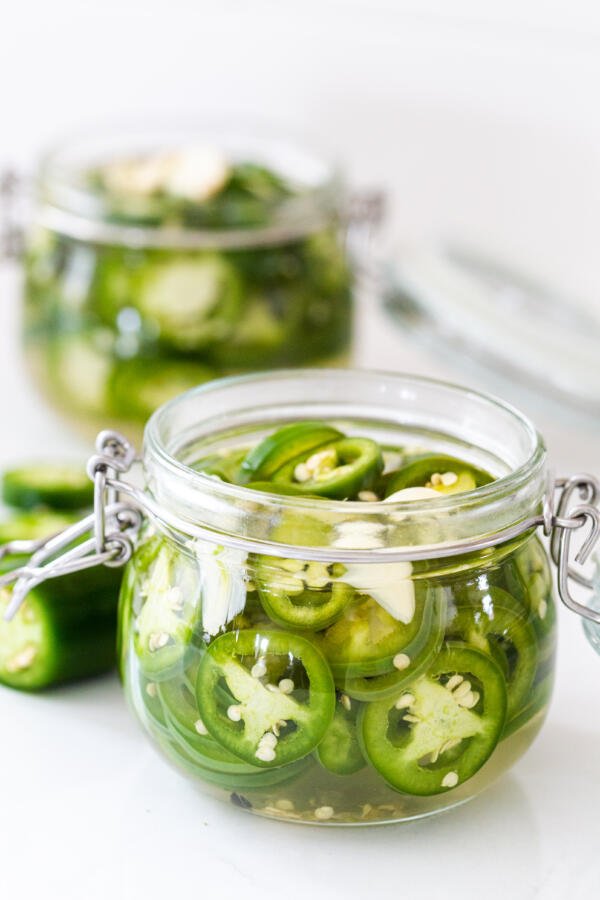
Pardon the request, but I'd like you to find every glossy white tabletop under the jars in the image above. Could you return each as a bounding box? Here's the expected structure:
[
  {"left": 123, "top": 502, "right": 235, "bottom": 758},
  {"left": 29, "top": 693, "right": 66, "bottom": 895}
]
[{"left": 0, "top": 260, "right": 600, "bottom": 900}]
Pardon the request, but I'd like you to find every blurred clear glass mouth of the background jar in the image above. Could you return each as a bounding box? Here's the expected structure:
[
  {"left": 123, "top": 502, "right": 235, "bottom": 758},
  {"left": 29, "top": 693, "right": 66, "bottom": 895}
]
[{"left": 37, "top": 117, "right": 344, "bottom": 250}]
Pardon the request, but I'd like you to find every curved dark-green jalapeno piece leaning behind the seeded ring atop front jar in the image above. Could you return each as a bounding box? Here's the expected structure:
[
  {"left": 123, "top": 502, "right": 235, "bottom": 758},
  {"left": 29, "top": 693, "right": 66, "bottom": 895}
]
[{"left": 239, "top": 422, "right": 342, "bottom": 484}]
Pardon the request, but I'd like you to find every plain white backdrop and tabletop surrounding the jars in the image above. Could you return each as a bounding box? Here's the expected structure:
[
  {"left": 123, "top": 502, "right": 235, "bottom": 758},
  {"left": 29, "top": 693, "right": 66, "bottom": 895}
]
[{"left": 0, "top": 0, "right": 600, "bottom": 900}]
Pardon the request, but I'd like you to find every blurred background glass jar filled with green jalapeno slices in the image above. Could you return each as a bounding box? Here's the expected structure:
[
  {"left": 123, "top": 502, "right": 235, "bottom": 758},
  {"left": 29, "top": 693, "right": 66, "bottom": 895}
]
[{"left": 25, "top": 128, "right": 354, "bottom": 434}]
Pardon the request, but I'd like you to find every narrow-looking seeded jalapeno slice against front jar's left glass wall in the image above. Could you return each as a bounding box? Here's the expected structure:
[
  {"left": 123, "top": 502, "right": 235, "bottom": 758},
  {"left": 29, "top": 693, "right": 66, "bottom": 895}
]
[{"left": 134, "top": 542, "right": 200, "bottom": 681}]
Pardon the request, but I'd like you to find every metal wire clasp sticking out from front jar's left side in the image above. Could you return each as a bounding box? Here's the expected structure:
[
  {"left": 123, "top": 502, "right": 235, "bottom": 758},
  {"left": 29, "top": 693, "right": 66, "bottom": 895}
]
[{"left": 0, "top": 431, "right": 142, "bottom": 621}]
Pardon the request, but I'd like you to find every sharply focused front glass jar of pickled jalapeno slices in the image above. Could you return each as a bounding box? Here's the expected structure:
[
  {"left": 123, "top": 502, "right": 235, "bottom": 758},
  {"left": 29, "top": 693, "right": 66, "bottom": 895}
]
[{"left": 120, "top": 370, "right": 556, "bottom": 824}]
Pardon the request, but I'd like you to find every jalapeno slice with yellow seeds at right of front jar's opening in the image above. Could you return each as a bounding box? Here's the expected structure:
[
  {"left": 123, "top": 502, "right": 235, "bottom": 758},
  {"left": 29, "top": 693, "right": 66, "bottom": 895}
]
[{"left": 385, "top": 454, "right": 492, "bottom": 497}]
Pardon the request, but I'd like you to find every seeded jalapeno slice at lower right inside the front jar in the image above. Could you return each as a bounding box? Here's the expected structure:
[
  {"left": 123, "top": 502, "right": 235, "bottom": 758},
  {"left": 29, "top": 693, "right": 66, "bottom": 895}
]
[{"left": 361, "top": 643, "right": 506, "bottom": 796}]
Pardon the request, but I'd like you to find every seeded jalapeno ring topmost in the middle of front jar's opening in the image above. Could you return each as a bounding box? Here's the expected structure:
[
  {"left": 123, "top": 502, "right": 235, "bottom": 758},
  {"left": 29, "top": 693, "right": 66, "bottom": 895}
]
[{"left": 273, "top": 437, "right": 383, "bottom": 500}]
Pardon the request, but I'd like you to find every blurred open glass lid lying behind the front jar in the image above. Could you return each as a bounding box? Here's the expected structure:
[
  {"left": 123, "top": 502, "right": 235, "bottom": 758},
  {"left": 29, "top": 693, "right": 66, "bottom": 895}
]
[{"left": 384, "top": 246, "right": 600, "bottom": 413}]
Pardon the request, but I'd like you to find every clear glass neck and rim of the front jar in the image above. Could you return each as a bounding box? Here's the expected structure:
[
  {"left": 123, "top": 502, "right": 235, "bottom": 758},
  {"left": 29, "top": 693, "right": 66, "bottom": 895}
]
[{"left": 144, "top": 369, "right": 547, "bottom": 561}]
